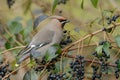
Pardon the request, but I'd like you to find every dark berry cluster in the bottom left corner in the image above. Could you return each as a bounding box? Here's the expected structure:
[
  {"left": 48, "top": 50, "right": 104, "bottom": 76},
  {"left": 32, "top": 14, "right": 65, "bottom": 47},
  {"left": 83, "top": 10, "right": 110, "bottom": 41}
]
[{"left": 0, "top": 62, "right": 11, "bottom": 80}]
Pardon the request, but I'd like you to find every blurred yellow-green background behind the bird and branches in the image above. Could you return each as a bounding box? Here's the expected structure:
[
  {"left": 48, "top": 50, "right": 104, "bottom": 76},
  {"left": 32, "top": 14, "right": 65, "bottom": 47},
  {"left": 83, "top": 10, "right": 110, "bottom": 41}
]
[{"left": 0, "top": 0, "right": 120, "bottom": 80}]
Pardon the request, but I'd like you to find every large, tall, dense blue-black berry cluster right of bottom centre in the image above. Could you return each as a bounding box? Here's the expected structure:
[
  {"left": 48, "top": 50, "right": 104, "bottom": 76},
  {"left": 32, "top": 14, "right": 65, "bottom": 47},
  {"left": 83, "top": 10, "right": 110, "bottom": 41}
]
[{"left": 70, "top": 56, "right": 85, "bottom": 80}]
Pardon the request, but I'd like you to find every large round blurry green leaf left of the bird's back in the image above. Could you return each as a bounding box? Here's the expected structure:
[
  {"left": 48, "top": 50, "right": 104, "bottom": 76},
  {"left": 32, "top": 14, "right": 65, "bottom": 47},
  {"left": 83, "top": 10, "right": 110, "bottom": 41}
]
[{"left": 8, "top": 21, "right": 22, "bottom": 34}]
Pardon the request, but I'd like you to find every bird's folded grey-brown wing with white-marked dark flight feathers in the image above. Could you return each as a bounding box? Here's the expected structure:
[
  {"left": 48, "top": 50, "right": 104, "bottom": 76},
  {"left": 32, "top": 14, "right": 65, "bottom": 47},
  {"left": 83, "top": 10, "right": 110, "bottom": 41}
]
[{"left": 18, "top": 30, "right": 54, "bottom": 56}]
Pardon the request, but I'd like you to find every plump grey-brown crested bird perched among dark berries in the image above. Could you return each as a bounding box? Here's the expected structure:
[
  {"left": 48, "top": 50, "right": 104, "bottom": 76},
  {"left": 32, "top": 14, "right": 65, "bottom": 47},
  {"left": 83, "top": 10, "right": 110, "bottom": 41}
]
[{"left": 17, "top": 15, "right": 69, "bottom": 64}]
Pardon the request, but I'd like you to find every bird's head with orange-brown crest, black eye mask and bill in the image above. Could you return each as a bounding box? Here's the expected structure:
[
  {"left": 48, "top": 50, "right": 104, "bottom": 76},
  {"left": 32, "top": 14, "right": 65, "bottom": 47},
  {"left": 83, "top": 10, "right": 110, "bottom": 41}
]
[{"left": 50, "top": 16, "right": 70, "bottom": 28}]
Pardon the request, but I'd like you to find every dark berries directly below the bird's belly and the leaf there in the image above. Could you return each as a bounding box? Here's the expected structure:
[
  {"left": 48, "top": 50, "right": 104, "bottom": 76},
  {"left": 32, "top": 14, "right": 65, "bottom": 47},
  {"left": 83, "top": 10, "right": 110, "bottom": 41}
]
[{"left": 34, "top": 56, "right": 60, "bottom": 72}]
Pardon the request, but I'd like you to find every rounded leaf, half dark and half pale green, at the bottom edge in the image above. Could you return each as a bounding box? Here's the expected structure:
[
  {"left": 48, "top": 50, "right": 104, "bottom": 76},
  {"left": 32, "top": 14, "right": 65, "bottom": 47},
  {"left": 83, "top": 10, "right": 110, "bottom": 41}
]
[{"left": 23, "top": 70, "right": 38, "bottom": 80}]
